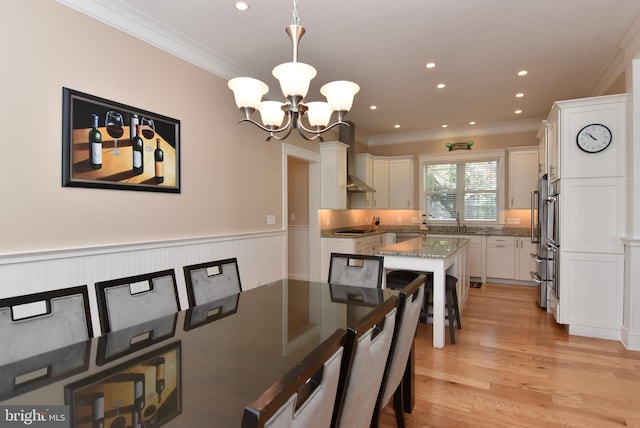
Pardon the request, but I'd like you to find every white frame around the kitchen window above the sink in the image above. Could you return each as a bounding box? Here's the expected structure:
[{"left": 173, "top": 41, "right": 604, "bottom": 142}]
[{"left": 418, "top": 149, "right": 506, "bottom": 226}]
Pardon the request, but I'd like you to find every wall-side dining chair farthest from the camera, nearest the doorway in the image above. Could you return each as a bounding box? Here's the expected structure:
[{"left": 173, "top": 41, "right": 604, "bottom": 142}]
[{"left": 183, "top": 257, "right": 242, "bottom": 308}]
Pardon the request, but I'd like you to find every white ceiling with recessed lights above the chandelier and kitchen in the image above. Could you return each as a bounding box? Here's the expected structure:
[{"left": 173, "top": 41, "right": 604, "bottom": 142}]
[{"left": 58, "top": 0, "right": 640, "bottom": 144}]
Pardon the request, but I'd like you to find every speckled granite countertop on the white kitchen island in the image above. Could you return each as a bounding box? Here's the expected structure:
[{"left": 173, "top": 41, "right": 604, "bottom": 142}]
[{"left": 375, "top": 237, "right": 469, "bottom": 259}]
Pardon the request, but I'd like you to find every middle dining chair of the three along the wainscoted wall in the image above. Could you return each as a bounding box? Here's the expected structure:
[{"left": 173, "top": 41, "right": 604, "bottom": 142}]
[{"left": 96, "top": 269, "right": 180, "bottom": 334}]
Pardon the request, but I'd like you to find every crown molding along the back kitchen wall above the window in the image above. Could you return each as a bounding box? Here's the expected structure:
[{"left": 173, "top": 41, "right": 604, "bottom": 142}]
[{"left": 367, "top": 118, "right": 545, "bottom": 147}]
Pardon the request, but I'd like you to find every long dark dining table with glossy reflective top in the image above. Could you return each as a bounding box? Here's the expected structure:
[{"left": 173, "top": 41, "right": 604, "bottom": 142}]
[{"left": 0, "top": 279, "right": 404, "bottom": 428}]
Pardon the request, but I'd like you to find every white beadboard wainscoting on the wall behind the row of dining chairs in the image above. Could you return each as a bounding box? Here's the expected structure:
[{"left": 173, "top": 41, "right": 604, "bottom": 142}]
[{"left": 0, "top": 231, "right": 286, "bottom": 335}]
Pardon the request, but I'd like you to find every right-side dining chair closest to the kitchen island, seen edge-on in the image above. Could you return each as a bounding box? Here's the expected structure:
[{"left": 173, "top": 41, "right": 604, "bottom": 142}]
[{"left": 371, "top": 274, "right": 426, "bottom": 428}]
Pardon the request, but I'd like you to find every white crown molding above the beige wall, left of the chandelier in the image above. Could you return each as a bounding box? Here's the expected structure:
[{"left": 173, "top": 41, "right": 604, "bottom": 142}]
[{"left": 57, "top": 0, "right": 252, "bottom": 80}]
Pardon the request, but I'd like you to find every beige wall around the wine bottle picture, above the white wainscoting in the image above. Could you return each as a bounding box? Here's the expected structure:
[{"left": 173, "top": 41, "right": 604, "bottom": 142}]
[{"left": 0, "top": 0, "right": 324, "bottom": 255}]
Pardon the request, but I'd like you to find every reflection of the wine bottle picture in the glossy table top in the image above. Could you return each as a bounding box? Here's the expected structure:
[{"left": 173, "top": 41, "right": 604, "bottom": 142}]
[{"left": 64, "top": 341, "right": 182, "bottom": 428}]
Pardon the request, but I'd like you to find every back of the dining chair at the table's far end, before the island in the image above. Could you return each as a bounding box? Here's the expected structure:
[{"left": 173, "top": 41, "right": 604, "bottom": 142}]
[{"left": 328, "top": 253, "right": 384, "bottom": 288}]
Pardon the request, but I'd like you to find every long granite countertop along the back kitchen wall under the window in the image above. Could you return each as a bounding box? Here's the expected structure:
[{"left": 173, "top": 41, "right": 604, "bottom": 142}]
[{"left": 321, "top": 225, "right": 531, "bottom": 239}]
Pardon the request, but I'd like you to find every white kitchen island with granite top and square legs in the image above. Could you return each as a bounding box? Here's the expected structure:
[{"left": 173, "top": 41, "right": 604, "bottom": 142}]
[{"left": 375, "top": 235, "right": 469, "bottom": 348}]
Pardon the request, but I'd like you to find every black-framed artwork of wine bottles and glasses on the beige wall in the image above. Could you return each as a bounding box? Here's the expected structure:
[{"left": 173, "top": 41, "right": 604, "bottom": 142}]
[{"left": 62, "top": 88, "right": 180, "bottom": 193}]
